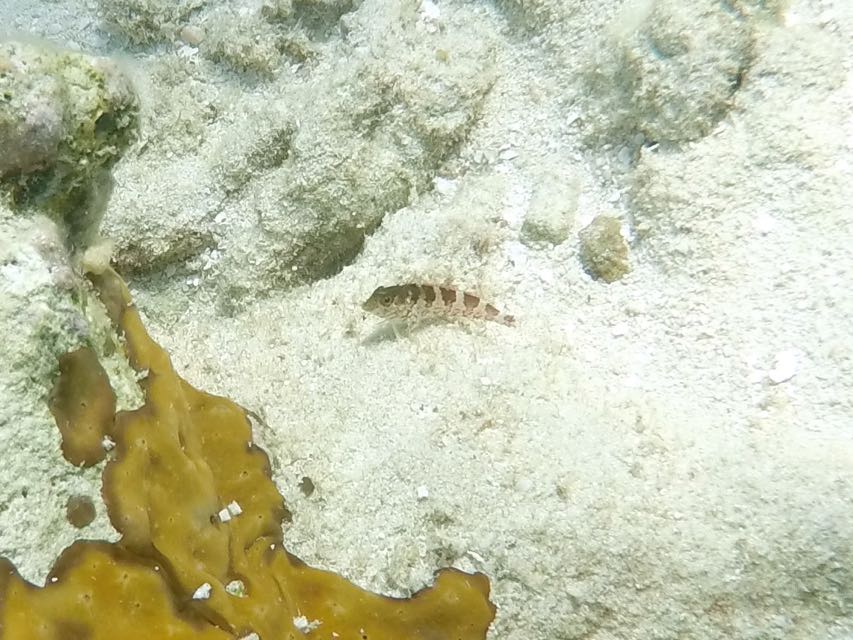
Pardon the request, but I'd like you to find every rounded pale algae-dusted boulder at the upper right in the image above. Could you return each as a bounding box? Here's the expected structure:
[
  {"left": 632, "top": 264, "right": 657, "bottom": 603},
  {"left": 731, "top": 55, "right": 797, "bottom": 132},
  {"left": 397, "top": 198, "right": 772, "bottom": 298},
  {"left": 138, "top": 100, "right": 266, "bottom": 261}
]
[{"left": 587, "top": 0, "right": 754, "bottom": 142}]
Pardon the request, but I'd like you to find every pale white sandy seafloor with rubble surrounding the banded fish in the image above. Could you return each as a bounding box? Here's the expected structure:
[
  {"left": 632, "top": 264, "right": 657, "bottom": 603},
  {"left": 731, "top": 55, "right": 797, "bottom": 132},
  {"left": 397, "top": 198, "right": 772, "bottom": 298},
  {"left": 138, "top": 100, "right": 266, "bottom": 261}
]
[{"left": 0, "top": 0, "right": 853, "bottom": 640}]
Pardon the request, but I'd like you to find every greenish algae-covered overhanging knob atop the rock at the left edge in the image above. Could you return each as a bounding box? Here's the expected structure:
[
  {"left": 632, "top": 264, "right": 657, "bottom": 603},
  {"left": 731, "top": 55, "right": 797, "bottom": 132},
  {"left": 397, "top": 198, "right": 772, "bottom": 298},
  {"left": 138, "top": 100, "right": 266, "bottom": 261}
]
[{"left": 0, "top": 42, "right": 137, "bottom": 244}]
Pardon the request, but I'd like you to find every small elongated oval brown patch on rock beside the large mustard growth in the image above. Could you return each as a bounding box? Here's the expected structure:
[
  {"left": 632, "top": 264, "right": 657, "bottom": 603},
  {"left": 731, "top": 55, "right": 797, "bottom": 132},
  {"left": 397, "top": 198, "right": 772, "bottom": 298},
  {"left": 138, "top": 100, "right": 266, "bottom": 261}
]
[{"left": 50, "top": 347, "right": 116, "bottom": 467}]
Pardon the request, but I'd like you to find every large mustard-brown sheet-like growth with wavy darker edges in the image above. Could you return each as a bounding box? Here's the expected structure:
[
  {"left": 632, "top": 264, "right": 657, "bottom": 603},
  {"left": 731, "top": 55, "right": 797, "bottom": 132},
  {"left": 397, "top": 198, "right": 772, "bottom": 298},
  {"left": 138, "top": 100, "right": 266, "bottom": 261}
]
[{"left": 0, "top": 270, "right": 495, "bottom": 640}]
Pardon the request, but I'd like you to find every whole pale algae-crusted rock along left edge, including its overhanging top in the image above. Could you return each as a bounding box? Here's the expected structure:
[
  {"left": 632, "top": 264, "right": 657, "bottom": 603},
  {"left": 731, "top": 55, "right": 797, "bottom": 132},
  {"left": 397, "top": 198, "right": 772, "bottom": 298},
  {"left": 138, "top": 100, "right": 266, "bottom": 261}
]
[{"left": 0, "top": 42, "right": 139, "bottom": 568}]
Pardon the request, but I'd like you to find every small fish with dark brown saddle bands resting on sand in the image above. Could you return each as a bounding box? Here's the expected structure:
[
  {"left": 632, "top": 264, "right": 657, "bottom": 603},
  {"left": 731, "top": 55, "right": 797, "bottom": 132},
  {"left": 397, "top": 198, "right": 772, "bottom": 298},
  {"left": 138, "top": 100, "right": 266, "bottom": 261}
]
[{"left": 361, "top": 284, "right": 515, "bottom": 327}]
